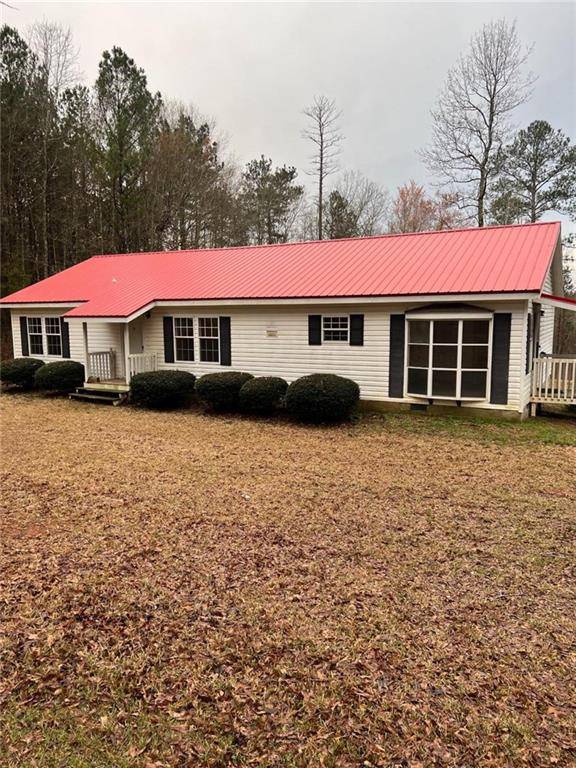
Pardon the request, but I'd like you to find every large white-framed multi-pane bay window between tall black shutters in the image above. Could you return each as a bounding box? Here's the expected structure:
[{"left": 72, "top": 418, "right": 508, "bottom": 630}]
[{"left": 406, "top": 318, "right": 491, "bottom": 400}]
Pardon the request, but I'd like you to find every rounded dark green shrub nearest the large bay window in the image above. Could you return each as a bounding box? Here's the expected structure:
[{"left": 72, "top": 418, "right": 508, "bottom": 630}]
[{"left": 286, "top": 373, "right": 360, "bottom": 422}]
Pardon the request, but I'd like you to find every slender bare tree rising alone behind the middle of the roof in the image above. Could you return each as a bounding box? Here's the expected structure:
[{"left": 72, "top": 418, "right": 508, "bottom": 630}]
[{"left": 302, "top": 96, "right": 343, "bottom": 240}]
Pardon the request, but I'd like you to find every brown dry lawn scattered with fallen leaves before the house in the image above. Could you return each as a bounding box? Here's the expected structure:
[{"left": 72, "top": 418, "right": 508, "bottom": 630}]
[{"left": 0, "top": 395, "right": 576, "bottom": 768}]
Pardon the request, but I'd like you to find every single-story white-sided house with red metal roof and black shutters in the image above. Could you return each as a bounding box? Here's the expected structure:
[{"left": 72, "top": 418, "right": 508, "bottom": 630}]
[{"left": 0, "top": 222, "right": 576, "bottom": 416}]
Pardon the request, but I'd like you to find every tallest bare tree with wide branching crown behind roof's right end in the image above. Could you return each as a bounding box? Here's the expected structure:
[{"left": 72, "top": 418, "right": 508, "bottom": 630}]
[{"left": 421, "top": 19, "right": 534, "bottom": 227}]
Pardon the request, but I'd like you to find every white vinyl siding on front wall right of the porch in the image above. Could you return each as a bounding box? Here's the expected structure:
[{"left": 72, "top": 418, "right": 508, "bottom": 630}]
[{"left": 144, "top": 301, "right": 527, "bottom": 410}]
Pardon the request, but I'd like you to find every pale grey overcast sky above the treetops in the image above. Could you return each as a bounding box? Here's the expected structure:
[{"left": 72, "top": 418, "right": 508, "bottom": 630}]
[{"left": 3, "top": 0, "right": 576, "bottom": 236}]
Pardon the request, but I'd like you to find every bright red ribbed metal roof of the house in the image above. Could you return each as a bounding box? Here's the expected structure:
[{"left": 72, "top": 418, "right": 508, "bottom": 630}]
[{"left": 1, "top": 222, "right": 560, "bottom": 317}]
